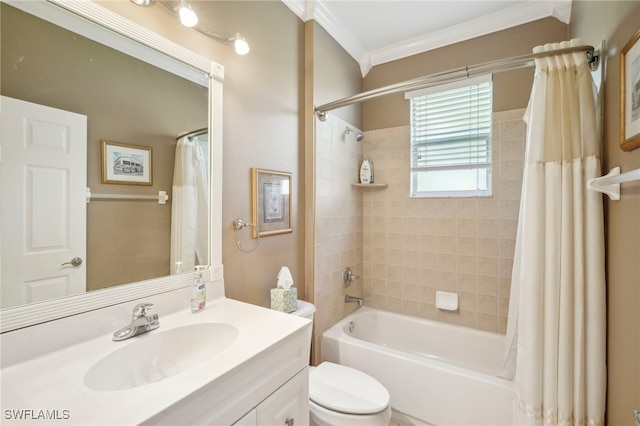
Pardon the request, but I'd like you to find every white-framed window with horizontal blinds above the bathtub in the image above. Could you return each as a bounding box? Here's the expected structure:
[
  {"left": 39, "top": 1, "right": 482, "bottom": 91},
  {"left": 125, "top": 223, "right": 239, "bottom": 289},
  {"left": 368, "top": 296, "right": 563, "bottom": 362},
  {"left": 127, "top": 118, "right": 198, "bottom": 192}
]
[{"left": 405, "top": 75, "right": 492, "bottom": 197}]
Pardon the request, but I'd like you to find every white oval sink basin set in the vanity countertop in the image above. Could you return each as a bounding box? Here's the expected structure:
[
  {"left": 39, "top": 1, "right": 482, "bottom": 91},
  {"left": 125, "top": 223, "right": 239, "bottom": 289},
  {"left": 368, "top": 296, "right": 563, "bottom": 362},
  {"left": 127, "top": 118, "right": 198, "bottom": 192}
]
[{"left": 84, "top": 322, "right": 238, "bottom": 391}]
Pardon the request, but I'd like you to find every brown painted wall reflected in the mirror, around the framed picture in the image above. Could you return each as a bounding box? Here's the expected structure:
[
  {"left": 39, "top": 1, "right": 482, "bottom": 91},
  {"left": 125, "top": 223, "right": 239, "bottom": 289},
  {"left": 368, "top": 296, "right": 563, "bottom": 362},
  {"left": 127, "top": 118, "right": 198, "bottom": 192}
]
[{"left": 0, "top": 3, "right": 208, "bottom": 290}]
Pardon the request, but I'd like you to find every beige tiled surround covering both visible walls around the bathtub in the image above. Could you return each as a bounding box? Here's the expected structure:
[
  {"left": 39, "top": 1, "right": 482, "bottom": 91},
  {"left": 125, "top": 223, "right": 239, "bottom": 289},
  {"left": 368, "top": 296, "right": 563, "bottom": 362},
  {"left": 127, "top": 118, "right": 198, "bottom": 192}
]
[{"left": 314, "top": 109, "right": 525, "bottom": 361}]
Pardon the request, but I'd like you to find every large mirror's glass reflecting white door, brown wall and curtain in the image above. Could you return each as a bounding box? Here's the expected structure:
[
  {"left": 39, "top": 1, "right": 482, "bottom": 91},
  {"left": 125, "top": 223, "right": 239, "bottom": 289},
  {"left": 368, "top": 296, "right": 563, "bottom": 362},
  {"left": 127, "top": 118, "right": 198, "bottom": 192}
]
[{"left": 0, "top": 2, "right": 209, "bottom": 308}]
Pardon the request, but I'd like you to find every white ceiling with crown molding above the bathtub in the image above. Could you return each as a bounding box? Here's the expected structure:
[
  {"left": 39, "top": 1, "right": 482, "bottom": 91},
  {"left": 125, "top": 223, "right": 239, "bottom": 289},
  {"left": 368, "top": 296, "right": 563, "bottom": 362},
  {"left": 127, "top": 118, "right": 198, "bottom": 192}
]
[{"left": 282, "top": 0, "right": 572, "bottom": 76}]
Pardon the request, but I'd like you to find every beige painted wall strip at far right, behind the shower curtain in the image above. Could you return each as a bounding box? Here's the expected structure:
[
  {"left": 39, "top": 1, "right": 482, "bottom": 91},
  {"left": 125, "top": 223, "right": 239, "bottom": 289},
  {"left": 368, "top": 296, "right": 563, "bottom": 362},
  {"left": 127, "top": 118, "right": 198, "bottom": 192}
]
[{"left": 571, "top": 0, "right": 640, "bottom": 425}]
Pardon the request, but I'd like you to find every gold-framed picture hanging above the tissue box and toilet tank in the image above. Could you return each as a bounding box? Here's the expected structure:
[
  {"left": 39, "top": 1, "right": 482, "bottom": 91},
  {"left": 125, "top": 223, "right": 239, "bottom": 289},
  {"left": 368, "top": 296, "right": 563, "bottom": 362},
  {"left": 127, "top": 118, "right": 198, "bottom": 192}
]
[{"left": 251, "top": 168, "right": 293, "bottom": 238}]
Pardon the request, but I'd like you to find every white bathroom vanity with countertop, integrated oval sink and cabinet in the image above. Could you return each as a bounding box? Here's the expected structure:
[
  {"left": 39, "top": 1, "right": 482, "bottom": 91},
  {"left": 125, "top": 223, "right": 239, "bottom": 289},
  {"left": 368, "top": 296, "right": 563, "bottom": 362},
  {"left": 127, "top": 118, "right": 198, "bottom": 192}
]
[{"left": 0, "top": 281, "right": 311, "bottom": 425}]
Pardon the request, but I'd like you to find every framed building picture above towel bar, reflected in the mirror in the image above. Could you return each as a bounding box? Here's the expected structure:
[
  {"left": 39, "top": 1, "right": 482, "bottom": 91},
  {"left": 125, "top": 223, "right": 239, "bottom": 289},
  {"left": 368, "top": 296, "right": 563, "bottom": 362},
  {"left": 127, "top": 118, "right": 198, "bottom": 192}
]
[{"left": 102, "top": 141, "right": 153, "bottom": 185}]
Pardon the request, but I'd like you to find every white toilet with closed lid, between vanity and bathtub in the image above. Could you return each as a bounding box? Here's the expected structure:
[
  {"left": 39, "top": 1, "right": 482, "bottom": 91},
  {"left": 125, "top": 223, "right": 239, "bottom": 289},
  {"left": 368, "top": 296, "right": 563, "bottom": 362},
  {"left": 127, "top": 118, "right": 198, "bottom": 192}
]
[{"left": 292, "top": 300, "right": 391, "bottom": 426}]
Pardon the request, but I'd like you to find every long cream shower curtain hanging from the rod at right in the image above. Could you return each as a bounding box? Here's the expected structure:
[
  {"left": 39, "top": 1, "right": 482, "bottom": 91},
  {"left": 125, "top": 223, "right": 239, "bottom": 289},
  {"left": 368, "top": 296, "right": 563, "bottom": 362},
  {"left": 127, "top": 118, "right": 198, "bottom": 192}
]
[{"left": 501, "top": 40, "right": 606, "bottom": 425}]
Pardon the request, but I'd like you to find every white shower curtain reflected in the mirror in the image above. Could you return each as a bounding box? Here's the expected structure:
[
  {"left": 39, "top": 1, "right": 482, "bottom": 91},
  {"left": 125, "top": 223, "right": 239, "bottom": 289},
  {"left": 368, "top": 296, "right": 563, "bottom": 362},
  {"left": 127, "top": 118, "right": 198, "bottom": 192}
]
[{"left": 169, "top": 132, "right": 209, "bottom": 273}]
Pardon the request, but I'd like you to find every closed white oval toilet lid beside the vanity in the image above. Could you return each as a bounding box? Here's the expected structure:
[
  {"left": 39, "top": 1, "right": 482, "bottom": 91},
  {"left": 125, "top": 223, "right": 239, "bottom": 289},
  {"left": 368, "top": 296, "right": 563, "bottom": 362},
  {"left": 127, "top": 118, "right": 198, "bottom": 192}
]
[{"left": 309, "top": 362, "right": 389, "bottom": 414}]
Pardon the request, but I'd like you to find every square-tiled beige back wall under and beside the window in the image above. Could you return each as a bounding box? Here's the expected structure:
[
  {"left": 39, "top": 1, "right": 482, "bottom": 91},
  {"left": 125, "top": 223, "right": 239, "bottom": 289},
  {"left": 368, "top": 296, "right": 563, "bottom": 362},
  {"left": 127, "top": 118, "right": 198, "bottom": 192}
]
[{"left": 363, "top": 109, "right": 525, "bottom": 333}]
